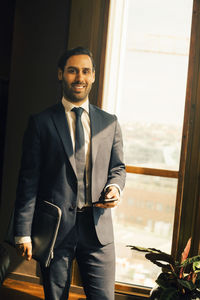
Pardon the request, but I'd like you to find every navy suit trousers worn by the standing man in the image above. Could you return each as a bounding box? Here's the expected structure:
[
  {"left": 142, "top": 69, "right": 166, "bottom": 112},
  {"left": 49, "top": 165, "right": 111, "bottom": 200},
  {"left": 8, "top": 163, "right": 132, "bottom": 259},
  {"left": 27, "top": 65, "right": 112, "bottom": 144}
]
[{"left": 41, "top": 208, "right": 115, "bottom": 300}]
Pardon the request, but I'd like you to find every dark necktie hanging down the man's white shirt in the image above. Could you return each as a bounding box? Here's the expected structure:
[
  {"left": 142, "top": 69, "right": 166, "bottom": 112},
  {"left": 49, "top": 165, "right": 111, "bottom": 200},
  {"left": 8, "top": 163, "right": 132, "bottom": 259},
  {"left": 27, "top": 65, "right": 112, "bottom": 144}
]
[{"left": 72, "top": 107, "right": 85, "bottom": 208}]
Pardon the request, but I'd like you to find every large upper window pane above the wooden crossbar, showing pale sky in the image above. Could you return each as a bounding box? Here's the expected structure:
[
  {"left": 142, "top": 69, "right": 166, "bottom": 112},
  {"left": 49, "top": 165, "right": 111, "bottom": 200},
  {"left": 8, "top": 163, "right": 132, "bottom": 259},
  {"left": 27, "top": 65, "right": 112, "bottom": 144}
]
[{"left": 104, "top": 0, "right": 193, "bottom": 170}]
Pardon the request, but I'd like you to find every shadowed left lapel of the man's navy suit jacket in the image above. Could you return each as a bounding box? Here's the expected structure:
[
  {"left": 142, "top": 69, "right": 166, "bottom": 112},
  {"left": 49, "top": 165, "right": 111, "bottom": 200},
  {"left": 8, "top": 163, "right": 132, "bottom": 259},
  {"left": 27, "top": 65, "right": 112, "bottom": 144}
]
[{"left": 52, "top": 103, "right": 76, "bottom": 175}]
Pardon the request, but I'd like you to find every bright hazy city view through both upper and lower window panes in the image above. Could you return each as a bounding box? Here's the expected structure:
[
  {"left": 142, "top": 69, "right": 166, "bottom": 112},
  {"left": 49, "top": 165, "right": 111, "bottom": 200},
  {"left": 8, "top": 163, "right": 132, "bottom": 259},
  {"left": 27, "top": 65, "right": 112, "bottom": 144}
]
[{"left": 104, "top": 0, "right": 193, "bottom": 287}]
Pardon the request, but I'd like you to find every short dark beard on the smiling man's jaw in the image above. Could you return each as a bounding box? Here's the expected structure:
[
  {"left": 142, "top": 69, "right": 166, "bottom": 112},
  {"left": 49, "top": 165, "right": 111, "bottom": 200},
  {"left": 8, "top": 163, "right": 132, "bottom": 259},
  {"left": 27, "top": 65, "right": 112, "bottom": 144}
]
[{"left": 62, "top": 79, "right": 92, "bottom": 103}]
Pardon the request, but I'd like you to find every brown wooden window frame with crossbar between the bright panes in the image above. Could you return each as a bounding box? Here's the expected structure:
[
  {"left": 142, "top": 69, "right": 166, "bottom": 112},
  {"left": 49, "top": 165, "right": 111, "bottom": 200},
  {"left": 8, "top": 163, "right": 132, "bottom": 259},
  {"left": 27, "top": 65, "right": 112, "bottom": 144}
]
[{"left": 98, "top": 0, "right": 200, "bottom": 298}]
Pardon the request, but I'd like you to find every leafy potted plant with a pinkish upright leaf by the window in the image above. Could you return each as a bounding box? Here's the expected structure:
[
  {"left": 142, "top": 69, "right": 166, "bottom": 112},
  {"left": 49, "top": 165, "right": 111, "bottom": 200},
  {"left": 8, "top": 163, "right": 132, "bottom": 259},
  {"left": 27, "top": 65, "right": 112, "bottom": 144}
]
[{"left": 128, "top": 238, "right": 200, "bottom": 300}]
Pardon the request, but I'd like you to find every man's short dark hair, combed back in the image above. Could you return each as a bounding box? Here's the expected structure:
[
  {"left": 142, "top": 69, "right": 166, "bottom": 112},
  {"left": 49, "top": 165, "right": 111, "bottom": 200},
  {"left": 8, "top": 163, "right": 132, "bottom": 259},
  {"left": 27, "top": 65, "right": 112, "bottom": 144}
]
[{"left": 58, "top": 47, "right": 95, "bottom": 72}]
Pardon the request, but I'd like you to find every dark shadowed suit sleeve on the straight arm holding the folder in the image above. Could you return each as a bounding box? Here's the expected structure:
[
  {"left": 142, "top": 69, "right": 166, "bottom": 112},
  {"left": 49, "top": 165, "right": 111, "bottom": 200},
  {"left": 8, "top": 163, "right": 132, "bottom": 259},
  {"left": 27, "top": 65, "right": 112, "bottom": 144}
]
[{"left": 14, "top": 117, "right": 40, "bottom": 236}]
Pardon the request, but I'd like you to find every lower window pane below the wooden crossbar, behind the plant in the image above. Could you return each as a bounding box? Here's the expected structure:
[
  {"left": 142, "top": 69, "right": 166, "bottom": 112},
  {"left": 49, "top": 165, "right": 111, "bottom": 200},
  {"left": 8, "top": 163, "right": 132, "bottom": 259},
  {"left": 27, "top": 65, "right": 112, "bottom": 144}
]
[{"left": 113, "top": 174, "right": 177, "bottom": 286}]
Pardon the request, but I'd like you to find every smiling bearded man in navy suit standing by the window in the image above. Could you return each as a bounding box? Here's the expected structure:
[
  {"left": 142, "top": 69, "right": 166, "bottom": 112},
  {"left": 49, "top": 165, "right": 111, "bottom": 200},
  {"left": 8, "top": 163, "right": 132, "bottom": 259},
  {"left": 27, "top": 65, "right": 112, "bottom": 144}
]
[{"left": 15, "top": 47, "right": 125, "bottom": 300}]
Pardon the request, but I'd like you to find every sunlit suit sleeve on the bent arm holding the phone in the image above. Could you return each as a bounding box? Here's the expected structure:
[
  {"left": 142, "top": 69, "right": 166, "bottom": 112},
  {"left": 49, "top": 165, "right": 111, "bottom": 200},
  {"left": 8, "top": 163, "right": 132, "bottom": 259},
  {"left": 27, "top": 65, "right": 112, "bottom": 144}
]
[{"left": 106, "top": 120, "right": 126, "bottom": 190}]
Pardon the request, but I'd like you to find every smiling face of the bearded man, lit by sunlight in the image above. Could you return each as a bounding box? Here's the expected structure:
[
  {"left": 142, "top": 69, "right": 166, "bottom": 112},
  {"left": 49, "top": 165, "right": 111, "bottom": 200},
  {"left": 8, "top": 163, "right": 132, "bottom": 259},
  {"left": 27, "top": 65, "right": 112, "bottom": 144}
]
[{"left": 58, "top": 54, "right": 95, "bottom": 105}]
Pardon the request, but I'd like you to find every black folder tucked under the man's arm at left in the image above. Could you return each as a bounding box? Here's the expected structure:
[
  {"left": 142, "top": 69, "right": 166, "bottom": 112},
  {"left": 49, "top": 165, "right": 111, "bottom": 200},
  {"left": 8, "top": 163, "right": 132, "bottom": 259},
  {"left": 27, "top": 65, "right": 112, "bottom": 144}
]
[{"left": 5, "top": 201, "right": 62, "bottom": 267}]
